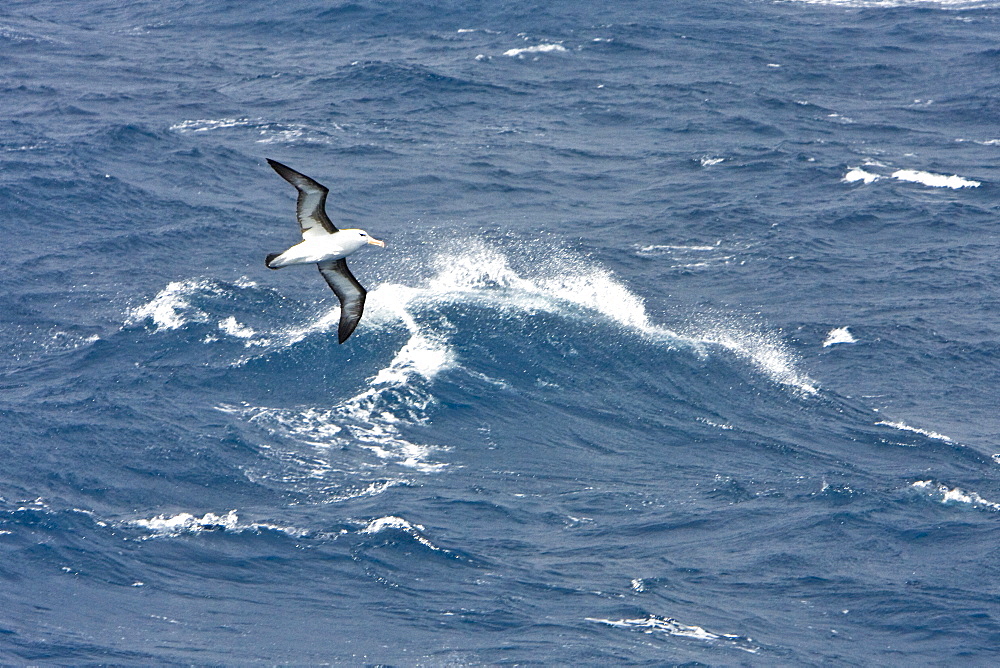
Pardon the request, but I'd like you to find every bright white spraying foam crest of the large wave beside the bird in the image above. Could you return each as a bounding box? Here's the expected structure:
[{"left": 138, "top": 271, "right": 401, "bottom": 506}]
[{"left": 126, "top": 239, "right": 818, "bottom": 400}]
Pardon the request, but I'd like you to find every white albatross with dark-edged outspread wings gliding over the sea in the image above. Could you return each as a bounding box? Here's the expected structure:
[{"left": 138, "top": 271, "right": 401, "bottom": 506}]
[{"left": 266, "top": 159, "right": 385, "bottom": 343}]
